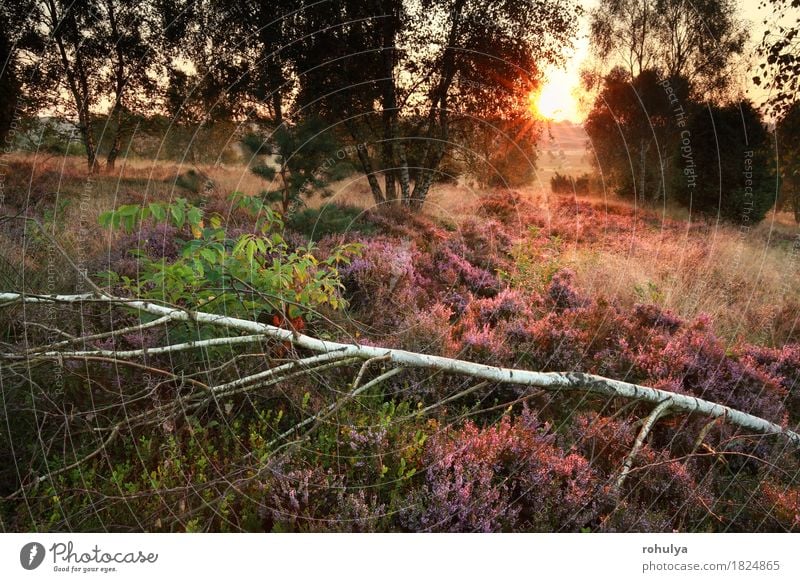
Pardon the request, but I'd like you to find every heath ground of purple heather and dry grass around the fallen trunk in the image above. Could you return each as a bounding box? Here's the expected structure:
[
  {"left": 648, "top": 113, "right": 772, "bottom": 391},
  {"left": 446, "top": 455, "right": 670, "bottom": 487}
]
[{"left": 0, "top": 158, "right": 800, "bottom": 531}]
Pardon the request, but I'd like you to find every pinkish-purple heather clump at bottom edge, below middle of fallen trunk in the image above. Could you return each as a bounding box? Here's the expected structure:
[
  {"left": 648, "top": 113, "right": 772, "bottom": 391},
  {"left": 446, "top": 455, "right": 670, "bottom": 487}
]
[{"left": 403, "top": 413, "right": 599, "bottom": 532}]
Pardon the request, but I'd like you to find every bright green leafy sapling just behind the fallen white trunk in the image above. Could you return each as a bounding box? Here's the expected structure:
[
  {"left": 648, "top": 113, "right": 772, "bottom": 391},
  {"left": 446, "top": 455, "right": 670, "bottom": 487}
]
[{"left": 100, "top": 192, "right": 358, "bottom": 317}]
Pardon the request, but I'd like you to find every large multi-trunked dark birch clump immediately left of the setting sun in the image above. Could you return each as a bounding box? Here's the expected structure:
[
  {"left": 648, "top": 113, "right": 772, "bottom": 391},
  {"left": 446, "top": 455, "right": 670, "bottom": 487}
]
[{"left": 290, "top": 0, "right": 576, "bottom": 208}]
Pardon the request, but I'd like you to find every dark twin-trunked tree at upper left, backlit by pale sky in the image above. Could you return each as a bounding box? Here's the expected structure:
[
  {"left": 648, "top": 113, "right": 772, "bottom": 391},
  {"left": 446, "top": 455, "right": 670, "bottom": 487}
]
[{"left": 27, "top": 0, "right": 165, "bottom": 171}]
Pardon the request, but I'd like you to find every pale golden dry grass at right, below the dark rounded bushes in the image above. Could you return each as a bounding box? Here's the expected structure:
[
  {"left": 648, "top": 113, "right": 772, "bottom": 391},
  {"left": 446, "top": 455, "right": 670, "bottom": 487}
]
[{"left": 562, "top": 197, "right": 800, "bottom": 352}]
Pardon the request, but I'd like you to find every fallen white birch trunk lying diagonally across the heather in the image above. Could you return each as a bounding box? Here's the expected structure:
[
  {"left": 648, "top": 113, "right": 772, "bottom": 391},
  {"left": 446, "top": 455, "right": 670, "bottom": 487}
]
[{"left": 0, "top": 293, "right": 800, "bottom": 446}]
